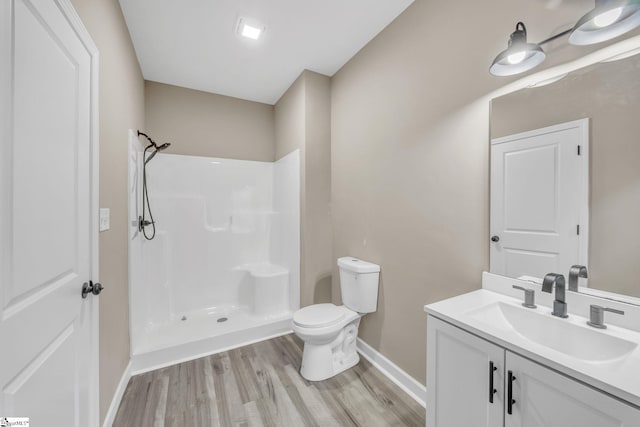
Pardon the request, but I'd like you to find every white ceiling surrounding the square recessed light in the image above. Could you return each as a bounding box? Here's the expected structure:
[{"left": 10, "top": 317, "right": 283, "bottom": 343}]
[{"left": 120, "top": 0, "right": 413, "bottom": 104}]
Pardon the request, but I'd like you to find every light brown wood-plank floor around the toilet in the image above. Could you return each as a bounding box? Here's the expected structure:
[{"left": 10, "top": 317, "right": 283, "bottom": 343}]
[{"left": 113, "top": 335, "right": 425, "bottom": 427}]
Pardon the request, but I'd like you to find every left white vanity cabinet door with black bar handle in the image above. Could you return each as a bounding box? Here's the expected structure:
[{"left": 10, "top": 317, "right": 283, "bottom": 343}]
[{"left": 427, "top": 316, "right": 505, "bottom": 427}]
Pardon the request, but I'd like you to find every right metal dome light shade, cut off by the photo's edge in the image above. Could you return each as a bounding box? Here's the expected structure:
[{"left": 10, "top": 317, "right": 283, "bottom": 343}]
[{"left": 569, "top": 0, "right": 640, "bottom": 45}]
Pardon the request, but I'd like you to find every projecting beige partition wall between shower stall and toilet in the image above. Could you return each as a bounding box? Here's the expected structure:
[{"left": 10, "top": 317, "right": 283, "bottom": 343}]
[{"left": 275, "top": 71, "right": 333, "bottom": 307}]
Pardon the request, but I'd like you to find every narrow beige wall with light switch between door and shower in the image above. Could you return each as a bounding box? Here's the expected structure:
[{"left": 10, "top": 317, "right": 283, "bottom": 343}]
[{"left": 73, "top": 0, "right": 144, "bottom": 422}]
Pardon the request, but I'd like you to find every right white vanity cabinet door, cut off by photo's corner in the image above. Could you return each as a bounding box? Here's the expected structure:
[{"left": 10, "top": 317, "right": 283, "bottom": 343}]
[{"left": 504, "top": 351, "right": 640, "bottom": 427}]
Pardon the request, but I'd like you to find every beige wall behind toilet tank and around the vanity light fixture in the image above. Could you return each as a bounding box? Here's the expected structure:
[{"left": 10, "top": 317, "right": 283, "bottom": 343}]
[{"left": 331, "top": 0, "right": 620, "bottom": 382}]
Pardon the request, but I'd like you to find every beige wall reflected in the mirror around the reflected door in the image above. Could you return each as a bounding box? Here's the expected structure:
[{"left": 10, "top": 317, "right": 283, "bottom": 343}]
[{"left": 491, "top": 56, "right": 640, "bottom": 297}]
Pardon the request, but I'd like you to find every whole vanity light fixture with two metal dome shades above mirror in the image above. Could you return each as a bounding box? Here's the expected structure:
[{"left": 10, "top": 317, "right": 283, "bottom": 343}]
[{"left": 489, "top": 0, "right": 640, "bottom": 76}]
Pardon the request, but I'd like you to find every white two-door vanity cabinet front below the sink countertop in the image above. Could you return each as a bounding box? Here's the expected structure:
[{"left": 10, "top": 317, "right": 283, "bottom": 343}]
[{"left": 427, "top": 316, "right": 640, "bottom": 427}]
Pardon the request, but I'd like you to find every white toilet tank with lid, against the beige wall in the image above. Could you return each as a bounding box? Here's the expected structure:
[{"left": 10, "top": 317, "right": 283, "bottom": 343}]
[{"left": 338, "top": 257, "right": 380, "bottom": 313}]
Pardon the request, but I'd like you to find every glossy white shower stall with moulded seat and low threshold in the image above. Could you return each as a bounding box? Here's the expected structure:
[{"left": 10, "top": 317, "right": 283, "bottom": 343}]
[{"left": 129, "top": 133, "right": 300, "bottom": 372}]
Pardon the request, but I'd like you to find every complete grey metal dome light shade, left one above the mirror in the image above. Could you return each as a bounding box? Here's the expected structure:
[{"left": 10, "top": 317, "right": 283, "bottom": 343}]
[{"left": 489, "top": 22, "right": 546, "bottom": 76}]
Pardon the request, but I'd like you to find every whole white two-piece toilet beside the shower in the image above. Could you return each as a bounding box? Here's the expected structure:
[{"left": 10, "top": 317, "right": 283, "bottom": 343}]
[{"left": 293, "top": 257, "right": 380, "bottom": 381}]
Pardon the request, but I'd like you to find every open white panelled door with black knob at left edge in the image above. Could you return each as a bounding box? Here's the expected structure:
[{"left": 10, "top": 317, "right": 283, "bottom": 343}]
[{"left": 0, "top": 0, "right": 98, "bottom": 427}]
